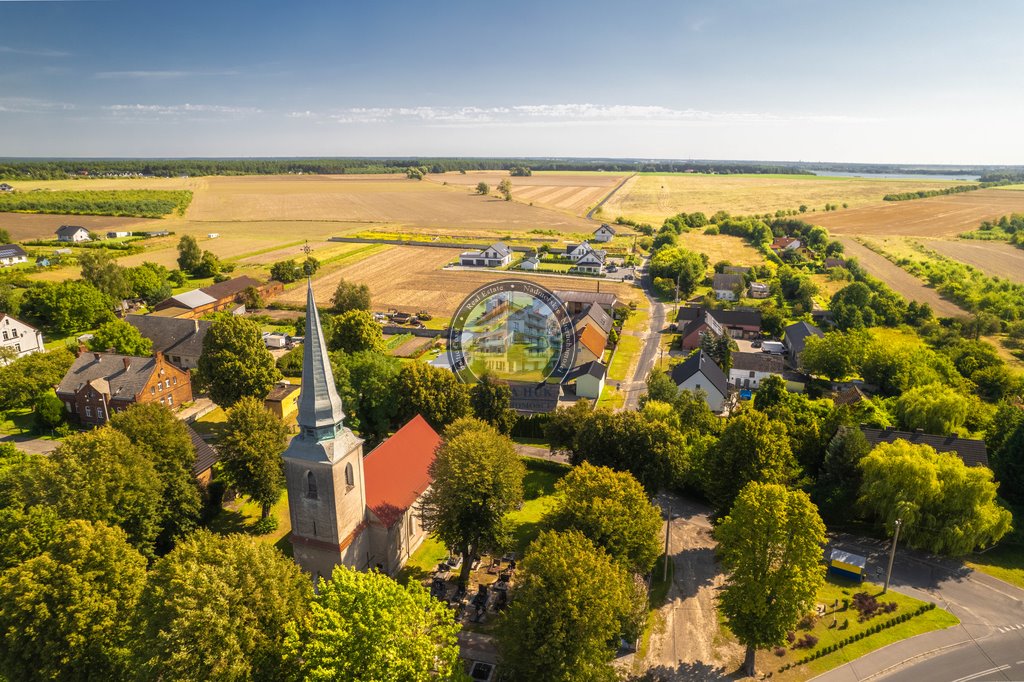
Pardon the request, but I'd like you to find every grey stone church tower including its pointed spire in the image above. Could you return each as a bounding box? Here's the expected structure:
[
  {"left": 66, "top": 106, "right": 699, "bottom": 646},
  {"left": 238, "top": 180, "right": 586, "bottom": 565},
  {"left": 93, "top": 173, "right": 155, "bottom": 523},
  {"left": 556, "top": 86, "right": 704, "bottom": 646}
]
[{"left": 284, "top": 283, "right": 370, "bottom": 581}]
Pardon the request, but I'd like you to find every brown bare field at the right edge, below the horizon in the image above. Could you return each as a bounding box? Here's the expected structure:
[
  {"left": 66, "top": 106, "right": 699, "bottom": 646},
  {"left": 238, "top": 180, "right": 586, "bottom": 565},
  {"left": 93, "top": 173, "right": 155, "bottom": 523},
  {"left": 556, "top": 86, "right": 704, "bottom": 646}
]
[{"left": 805, "top": 189, "right": 1024, "bottom": 237}]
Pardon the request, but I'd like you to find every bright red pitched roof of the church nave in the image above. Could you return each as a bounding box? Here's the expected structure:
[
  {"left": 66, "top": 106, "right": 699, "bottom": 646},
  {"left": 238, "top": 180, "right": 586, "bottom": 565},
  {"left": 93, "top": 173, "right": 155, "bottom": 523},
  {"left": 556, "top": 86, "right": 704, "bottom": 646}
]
[{"left": 362, "top": 415, "right": 441, "bottom": 528}]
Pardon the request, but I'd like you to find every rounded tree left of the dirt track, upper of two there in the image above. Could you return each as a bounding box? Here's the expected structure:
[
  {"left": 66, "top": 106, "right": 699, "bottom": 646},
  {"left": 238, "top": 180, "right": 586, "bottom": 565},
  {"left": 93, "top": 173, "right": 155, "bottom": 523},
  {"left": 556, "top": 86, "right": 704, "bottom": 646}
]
[{"left": 545, "top": 462, "right": 662, "bottom": 573}]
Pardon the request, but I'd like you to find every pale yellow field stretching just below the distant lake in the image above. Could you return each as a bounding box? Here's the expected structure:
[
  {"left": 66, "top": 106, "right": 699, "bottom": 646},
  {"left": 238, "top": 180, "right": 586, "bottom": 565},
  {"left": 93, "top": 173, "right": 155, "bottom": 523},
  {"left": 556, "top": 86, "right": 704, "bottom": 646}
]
[{"left": 603, "top": 173, "right": 975, "bottom": 224}]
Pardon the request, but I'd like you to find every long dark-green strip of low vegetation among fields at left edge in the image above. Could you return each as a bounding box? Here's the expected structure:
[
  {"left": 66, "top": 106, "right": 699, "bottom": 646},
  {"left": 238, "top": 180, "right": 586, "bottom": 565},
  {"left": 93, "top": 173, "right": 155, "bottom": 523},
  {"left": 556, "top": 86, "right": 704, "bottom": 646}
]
[{"left": 0, "top": 189, "right": 191, "bottom": 218}]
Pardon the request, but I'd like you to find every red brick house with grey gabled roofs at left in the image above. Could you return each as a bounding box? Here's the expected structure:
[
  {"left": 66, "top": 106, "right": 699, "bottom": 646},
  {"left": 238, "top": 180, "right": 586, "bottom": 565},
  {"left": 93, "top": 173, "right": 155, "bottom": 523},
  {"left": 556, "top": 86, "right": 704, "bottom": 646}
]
[{"left": 56, "top": 352, "right": 193, "bottom": 426}]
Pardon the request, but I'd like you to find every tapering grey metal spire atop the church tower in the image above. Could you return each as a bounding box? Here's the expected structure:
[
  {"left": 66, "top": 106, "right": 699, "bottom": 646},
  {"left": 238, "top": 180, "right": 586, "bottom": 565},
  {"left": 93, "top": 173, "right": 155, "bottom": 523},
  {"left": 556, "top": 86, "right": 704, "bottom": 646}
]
[{"left": 298, "top": 280, "right": 345, "bottom": 432}]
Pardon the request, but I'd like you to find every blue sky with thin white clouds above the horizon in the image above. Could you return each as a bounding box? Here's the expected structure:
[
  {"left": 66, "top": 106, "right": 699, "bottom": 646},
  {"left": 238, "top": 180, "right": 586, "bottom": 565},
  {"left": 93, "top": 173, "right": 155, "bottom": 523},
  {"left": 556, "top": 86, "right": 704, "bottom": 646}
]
[{"left": 0, "top": 0, "right": 1024, "bottom": 164}]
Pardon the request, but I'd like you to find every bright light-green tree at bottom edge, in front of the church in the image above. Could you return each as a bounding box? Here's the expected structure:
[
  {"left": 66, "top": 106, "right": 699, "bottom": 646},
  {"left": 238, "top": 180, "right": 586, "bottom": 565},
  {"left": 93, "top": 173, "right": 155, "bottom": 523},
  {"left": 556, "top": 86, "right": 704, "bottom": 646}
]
[{"left": 286, "top": 565, "right": 464, "bottom": 682}]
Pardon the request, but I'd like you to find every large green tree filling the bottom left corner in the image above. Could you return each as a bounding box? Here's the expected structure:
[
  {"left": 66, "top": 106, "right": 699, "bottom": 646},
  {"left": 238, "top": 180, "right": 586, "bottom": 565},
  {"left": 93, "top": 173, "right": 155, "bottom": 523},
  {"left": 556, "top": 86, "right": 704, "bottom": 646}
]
[{"left": 0, "top": 520, "right": 145, "bottom": 680}]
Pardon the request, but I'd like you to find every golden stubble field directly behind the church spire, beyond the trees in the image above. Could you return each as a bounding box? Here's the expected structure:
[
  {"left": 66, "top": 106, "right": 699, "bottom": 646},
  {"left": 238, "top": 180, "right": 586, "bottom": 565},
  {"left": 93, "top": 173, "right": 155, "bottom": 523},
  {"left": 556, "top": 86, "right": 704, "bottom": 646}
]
[{"left": 276, "top": 247, "right": 642, "bottom": 317}]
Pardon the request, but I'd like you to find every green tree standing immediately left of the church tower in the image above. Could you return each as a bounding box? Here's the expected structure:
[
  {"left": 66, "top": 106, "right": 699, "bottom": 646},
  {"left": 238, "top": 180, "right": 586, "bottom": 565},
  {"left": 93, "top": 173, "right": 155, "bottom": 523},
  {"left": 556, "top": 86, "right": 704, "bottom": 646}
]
[{"left": 220, "top": 396, "right": 288, "bottom": 518}]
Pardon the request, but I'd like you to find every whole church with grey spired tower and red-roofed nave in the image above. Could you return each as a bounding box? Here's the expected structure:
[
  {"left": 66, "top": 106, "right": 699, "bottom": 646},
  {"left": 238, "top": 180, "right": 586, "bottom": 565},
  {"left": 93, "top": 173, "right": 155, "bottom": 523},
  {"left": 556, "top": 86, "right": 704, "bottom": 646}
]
[{"left": 283, "top": 284, "right": 441, "bottom": 581}]
